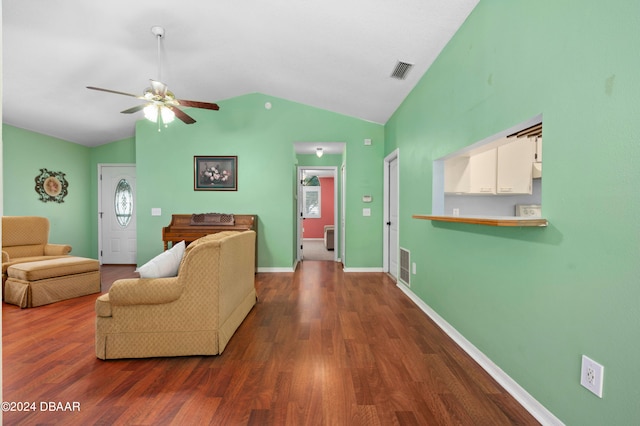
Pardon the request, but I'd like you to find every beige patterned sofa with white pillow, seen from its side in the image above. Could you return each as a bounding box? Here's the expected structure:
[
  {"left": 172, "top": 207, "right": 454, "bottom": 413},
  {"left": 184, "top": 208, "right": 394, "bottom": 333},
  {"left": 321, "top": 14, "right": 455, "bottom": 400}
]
[{"left": 95, "top": 231, "right": 256, "bottom": 359}]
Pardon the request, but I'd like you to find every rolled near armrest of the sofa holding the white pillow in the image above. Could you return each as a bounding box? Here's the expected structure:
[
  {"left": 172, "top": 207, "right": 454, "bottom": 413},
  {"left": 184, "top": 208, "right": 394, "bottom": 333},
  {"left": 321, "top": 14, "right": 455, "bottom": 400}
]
[{"left": 109, "top": 277, "right": 183, "bottom": 306}]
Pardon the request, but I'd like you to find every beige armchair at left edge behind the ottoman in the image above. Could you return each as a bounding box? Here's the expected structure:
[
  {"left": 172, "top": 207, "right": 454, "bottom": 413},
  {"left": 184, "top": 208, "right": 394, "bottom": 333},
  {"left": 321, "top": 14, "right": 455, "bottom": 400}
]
[{"left": 2, "top": 216, "right": 71, "bottom": 290}]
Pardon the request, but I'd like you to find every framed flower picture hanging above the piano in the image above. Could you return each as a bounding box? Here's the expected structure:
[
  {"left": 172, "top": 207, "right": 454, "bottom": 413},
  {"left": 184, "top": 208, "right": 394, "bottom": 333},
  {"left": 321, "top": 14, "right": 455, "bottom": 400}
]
[{"left": 193, "top": 155, "right": 238, "bottom": 191}]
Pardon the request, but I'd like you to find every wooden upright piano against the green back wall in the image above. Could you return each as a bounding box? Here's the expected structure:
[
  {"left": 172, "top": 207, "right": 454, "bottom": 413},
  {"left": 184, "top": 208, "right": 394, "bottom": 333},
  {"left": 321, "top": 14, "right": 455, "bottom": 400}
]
[{"left": 162, "top": 214, "right": 258, "bottom": 256}]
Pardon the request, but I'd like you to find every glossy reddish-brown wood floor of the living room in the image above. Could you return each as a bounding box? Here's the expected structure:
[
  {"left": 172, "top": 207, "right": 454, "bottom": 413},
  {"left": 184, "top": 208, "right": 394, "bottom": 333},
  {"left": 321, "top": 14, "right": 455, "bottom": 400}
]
[{"left": 2, "top": 261, "right": 537, "bottom": 425}]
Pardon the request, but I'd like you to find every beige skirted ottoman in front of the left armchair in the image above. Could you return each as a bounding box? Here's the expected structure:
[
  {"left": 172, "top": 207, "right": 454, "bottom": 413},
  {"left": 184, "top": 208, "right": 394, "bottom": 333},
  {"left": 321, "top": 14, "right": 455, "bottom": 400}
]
[{"left": 4, "top": 256, "right": 100, "bottom": 308}]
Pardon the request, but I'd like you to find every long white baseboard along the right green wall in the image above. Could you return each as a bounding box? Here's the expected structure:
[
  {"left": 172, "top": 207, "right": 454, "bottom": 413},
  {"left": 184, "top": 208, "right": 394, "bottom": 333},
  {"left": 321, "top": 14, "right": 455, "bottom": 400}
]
[{"left": 398, "top": 283, "right": 564, "bottom": 426}]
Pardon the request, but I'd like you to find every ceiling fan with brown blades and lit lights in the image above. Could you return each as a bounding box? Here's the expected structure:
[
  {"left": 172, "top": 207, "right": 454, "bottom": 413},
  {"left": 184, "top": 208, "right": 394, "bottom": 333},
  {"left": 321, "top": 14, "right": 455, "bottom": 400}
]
[{"left": 87, "top": 26, "right": 220, "bottom": 126}]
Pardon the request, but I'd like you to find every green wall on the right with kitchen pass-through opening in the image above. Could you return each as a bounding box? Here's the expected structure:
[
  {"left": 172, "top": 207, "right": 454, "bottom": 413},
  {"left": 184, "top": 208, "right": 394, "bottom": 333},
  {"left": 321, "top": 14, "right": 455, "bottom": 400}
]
[{"left": 385, "top": 0, "right": 640, "bottom": 425}]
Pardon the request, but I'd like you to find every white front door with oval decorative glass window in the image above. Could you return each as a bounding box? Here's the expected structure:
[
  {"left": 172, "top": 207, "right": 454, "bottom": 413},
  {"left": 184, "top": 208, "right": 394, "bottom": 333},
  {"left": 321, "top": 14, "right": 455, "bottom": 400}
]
[{"left": 98, "top": 164, "right": 137, "bottom": 265}]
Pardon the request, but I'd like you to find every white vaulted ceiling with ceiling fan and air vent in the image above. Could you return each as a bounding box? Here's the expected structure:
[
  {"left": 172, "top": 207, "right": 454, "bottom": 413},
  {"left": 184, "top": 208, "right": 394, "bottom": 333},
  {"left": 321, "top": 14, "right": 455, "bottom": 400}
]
[{"left": 2, "top": 0, "right": 479, "bottom": 146}]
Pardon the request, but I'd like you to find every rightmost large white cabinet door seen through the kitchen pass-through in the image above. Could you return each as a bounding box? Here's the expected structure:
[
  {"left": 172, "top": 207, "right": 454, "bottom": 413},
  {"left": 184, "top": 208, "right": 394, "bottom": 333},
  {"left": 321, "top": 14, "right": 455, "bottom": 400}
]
[{"left": 497, "top": 138, "right": 535, "bottom": 194}]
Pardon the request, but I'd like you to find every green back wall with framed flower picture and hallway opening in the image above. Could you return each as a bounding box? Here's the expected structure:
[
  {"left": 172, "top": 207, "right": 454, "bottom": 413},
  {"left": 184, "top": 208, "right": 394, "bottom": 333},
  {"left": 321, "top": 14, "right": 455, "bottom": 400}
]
[{"left": 136, "top": 94, "right": 384, "bottom": 268}]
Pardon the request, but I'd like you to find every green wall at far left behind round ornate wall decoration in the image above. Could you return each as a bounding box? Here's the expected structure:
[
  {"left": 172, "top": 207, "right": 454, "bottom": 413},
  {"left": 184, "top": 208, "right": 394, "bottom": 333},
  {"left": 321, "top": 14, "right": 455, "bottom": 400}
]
[{"left": 2, "top": 125, "right": 95, "bottom": 258}]
